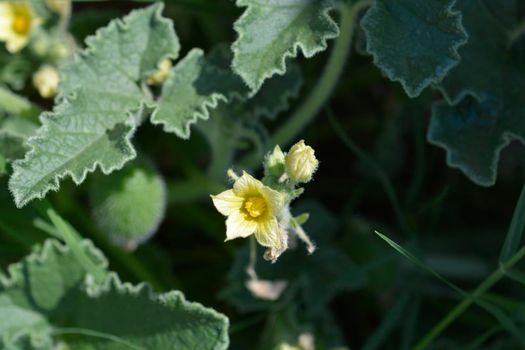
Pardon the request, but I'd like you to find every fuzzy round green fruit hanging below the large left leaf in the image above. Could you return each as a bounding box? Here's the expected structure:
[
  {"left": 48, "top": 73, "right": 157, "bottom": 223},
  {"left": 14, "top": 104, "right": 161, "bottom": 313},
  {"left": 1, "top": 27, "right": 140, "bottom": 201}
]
[{"left": 90, "top": 160, "right": 167, "bottom": 250}]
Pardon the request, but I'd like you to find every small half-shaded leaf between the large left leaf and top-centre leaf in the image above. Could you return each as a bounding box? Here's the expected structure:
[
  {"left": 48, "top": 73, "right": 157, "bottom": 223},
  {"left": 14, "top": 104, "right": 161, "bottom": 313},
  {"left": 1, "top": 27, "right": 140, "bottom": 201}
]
[{"left": 151, "top": 49, "right": 246, "bottom": 139}]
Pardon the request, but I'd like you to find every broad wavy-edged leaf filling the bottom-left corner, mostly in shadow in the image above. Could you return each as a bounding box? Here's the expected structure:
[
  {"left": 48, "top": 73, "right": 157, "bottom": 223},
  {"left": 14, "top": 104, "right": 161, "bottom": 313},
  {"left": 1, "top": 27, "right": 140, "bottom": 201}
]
[{"left": 0, "top": 240, "right": 228, "bottom": 350}]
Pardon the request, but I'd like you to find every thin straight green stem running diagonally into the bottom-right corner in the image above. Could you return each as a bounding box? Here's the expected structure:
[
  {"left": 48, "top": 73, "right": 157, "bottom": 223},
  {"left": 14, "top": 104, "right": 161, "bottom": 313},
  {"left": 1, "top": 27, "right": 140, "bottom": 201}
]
[{"left": 414, "top": 246, "right": 525, "bottom": 350}]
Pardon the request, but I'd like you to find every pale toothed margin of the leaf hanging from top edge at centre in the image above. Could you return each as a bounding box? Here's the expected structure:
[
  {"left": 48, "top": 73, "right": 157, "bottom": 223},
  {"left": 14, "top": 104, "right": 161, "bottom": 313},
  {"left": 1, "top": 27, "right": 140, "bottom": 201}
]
[{"left": 231, "top": 0, "right": 340, "bottom": 92}]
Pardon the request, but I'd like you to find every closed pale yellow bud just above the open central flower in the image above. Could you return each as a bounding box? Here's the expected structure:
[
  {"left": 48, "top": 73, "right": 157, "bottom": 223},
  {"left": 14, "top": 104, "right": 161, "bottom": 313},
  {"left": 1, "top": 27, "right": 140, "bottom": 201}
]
[{"left": 285, "top": 140, "right": 319, "bottom": 182}]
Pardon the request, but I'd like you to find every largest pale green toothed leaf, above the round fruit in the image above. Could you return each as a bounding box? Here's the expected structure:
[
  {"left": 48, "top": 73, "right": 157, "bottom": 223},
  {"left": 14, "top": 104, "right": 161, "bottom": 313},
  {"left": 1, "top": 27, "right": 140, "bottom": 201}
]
[{"left": 9, "top": 5, "right": 179, "bottom": 207}]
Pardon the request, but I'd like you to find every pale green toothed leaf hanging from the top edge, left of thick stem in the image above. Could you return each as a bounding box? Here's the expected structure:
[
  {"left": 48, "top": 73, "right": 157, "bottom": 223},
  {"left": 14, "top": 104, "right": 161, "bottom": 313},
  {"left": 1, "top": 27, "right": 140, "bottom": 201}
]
[{"left": 232, "top": 0, "right": 339, "bottom": 92}]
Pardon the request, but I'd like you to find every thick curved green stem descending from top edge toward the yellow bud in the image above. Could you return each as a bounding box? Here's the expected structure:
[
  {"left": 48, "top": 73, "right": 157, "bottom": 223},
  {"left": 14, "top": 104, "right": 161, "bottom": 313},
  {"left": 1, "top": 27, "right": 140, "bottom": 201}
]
[{"left": 242, "top": 0, "right": 372, "bottom": 168}]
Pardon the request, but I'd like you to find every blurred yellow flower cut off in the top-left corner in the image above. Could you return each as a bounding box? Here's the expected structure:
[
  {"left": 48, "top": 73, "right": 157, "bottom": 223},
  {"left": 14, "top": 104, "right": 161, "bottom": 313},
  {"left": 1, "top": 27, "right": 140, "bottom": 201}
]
[{"left": 0, "top": 0, "right": 40, "bottom": 53}]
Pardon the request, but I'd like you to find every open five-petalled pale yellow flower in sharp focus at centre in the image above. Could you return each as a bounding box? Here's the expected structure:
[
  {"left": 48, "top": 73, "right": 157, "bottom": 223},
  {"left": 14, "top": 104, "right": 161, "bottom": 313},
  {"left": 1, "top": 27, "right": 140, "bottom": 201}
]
[{"left": 211, "top": 172, "right": 287, "bottom": 250}]
